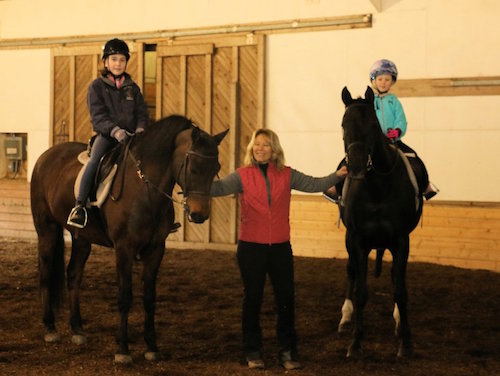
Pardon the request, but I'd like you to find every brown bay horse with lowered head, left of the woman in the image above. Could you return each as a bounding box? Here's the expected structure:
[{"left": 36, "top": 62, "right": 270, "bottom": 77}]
[{"left": 31, "top": 115, "right": 228, "bottom": 363}]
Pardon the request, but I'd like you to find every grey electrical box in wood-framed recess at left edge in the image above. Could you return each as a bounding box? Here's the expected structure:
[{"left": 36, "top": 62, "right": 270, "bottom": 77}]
[{"left": 0, "top": 133, "right": 28, "bottom": 179}]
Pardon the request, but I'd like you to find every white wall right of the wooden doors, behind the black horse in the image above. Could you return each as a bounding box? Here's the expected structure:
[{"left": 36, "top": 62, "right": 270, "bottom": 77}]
[{"left": 266, "top": 0, "right": 500, "bottom": 202}]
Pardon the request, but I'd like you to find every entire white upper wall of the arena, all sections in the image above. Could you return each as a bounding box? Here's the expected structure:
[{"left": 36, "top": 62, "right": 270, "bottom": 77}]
[{"left": 0, "top": 0, "right": 500, "bottom": 201}]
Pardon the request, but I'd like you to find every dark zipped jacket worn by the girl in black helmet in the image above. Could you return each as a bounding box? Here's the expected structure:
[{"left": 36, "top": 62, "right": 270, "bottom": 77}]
[{"left": 87, "top": 73, "right": 149, "bottom": 137}]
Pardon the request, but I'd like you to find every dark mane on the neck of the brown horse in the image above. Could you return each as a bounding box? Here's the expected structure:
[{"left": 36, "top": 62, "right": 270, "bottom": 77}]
[{"left": 136, "top": 115, "right": 193, "bottom": 160}]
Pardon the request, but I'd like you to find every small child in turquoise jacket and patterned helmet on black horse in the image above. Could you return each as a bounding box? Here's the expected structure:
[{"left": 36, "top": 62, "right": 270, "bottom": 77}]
[{"left": 370, "top": 59, "right": 439, "bottom": 200}]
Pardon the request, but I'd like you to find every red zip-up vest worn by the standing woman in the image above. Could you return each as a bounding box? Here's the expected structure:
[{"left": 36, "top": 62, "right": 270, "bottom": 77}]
[{"left": 237, "top": 163, "right": 291, "bottom": 244}]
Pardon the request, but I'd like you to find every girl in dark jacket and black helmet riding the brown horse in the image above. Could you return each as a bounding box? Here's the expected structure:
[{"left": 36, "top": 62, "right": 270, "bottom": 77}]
[{"left": 67, "top": 39, "right": 149, "bottom": 228}]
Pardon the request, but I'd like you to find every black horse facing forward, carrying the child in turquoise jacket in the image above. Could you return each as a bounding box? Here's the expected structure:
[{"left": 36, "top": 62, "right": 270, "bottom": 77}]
[{"left": 339, "top": 87, "right": 422, "bottom": 357}]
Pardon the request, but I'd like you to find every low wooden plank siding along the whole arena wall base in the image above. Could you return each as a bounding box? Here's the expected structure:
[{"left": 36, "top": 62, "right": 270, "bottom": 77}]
[{"left": 0, "top": 179, "right": 500, "bottom": 272}]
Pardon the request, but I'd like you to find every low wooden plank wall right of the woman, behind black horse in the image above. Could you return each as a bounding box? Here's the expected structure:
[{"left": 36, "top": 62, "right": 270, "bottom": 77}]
[{"left": 290, "top": 195, "right": 500, "bottom": 272}]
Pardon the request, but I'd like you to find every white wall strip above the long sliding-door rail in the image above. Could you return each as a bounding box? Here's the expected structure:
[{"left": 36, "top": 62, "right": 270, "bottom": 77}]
[{"left": 0, "top": 0, "right": 374, "bottom": 38}]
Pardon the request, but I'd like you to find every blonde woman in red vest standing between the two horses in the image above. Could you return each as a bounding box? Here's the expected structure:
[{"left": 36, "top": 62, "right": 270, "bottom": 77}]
[{"left": 211, "top": 129, "right": 347, "bottom": 370}]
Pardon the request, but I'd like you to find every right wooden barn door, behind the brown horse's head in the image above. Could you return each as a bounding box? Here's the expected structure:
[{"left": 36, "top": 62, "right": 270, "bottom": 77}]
[{"left": 156, "top": 35, "right": 264, "bottom": 244}]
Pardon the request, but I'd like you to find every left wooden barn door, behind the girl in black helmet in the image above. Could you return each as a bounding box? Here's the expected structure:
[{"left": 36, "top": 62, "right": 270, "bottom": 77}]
[{"left": 51, "top": 43, "right": 144, "bottom": 145}]
